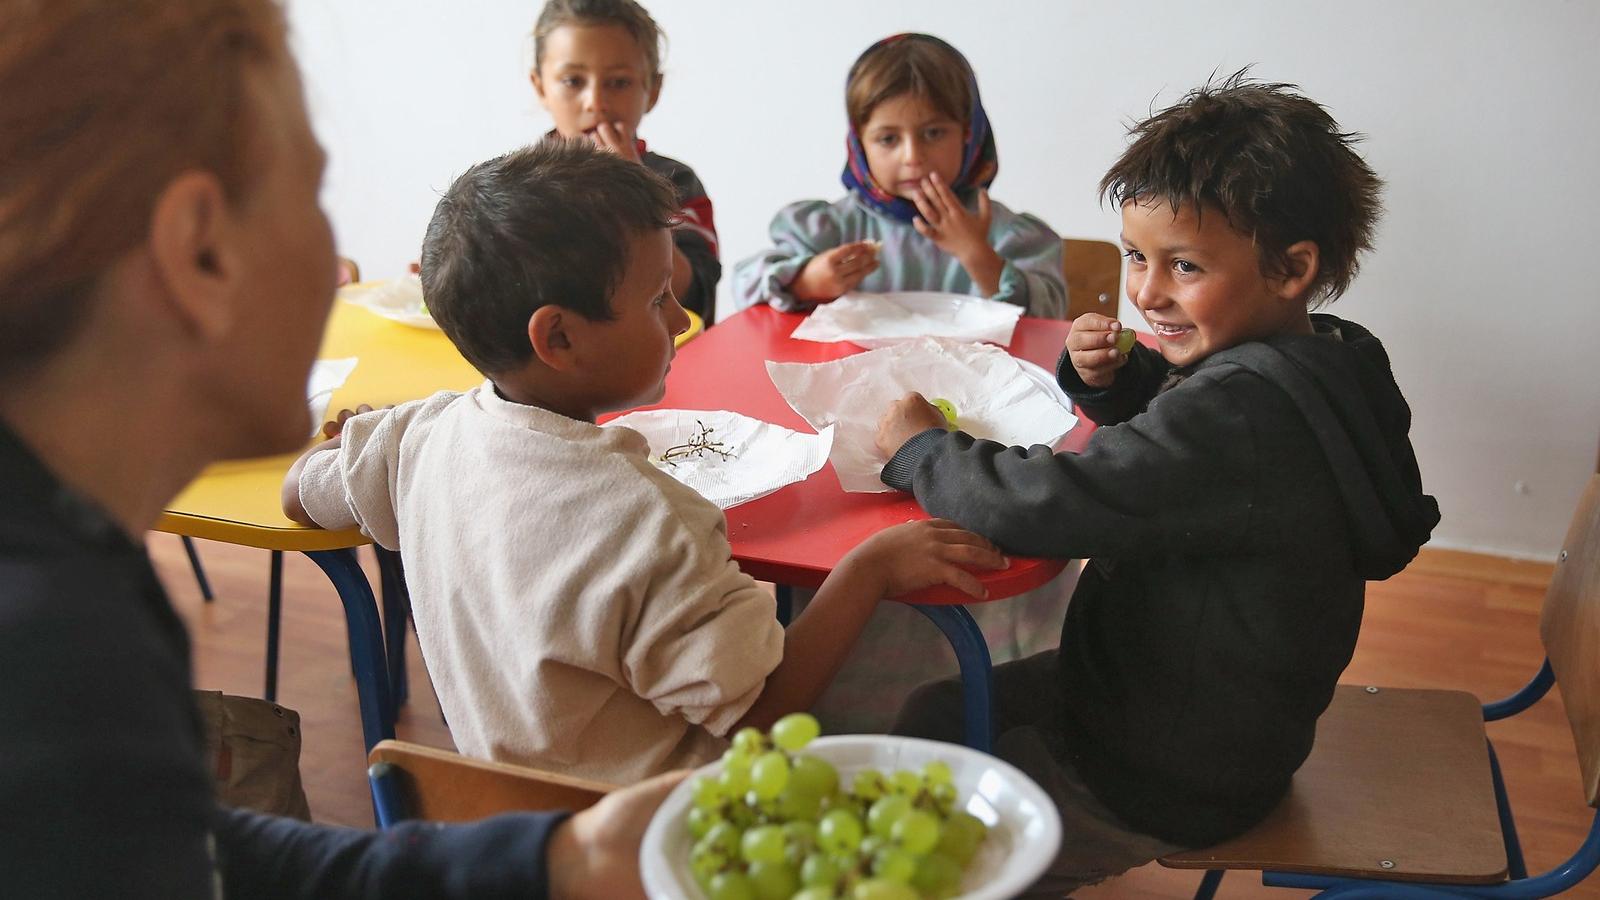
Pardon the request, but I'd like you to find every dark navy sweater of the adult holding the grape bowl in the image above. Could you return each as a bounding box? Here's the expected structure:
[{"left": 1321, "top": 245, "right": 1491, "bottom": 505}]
[{"left": 0, "top": 423, "right": 562, "bottom": 900}]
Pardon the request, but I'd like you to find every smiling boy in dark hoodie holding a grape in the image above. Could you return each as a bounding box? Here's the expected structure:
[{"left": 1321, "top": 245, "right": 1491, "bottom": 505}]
[{"left": 878, "top": 72, "right": 1438, "bottom": 895}]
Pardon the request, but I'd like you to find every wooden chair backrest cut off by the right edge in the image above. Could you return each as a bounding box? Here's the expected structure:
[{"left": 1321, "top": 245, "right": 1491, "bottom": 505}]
[{"left": 1539, "top": 474, "right": 1600, "bottom": 806}]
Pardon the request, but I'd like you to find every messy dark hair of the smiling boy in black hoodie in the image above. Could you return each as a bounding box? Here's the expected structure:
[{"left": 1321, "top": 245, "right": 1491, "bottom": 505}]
[{"left": 1099, "top": 69, "right": 1382, "bottom": 306}]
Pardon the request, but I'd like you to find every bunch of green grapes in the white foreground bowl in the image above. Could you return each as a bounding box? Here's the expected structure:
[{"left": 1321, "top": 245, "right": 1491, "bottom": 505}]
[{"left": 688, "top": 713, "right": 989, "bottom": 900}]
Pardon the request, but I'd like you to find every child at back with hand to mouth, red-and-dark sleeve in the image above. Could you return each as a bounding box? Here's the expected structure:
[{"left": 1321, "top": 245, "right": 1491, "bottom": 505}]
[{"left": 528, "top": 0, "right": 722, "bottom": 325}]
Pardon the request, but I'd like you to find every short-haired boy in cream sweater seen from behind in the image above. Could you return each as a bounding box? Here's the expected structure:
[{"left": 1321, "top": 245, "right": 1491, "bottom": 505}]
[{"left": 283, "top": 138, "right": 1005, "bottom": 783}]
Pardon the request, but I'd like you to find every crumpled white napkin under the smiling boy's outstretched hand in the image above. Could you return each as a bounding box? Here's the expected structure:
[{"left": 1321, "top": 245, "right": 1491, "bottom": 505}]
[{"left": 766, "top": 338, "right": 1078, "bottom": 492}]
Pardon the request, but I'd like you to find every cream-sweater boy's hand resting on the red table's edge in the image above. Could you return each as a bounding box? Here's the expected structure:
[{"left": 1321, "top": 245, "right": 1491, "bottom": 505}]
[{"left": 840, "top": 519, "right": 1011, "bottom": 601}]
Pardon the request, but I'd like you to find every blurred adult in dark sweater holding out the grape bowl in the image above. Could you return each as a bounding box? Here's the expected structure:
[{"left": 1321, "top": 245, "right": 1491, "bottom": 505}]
[{"left": 0, "top": 0, "right": 672, "bottom": 898}]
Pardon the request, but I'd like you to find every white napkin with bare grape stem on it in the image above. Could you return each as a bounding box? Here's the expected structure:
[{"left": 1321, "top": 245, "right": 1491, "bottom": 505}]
[{"left": 606, "top": 410, "right": 834, "bottom": 509}]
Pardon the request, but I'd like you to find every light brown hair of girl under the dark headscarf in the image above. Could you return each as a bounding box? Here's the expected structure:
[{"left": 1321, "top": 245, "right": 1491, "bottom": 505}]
[{"left": 845, "top": 34, "right": 973, "bottom": 131}]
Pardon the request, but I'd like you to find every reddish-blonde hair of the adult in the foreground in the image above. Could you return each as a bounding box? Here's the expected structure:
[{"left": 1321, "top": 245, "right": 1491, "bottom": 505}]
[{"left": 0, "top": 0, "right": 290, "bottom": 376}]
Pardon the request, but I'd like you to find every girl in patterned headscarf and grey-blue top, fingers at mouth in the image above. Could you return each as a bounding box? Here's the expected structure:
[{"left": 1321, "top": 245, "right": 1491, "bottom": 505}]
[{"left": 733, "top": 34, "right": 1067, "bottom": 319}]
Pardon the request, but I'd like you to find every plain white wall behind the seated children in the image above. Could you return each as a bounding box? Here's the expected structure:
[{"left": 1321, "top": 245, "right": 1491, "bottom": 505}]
[{"left": 290, "top": 0, "right": 1600, "bottom": 557}]
